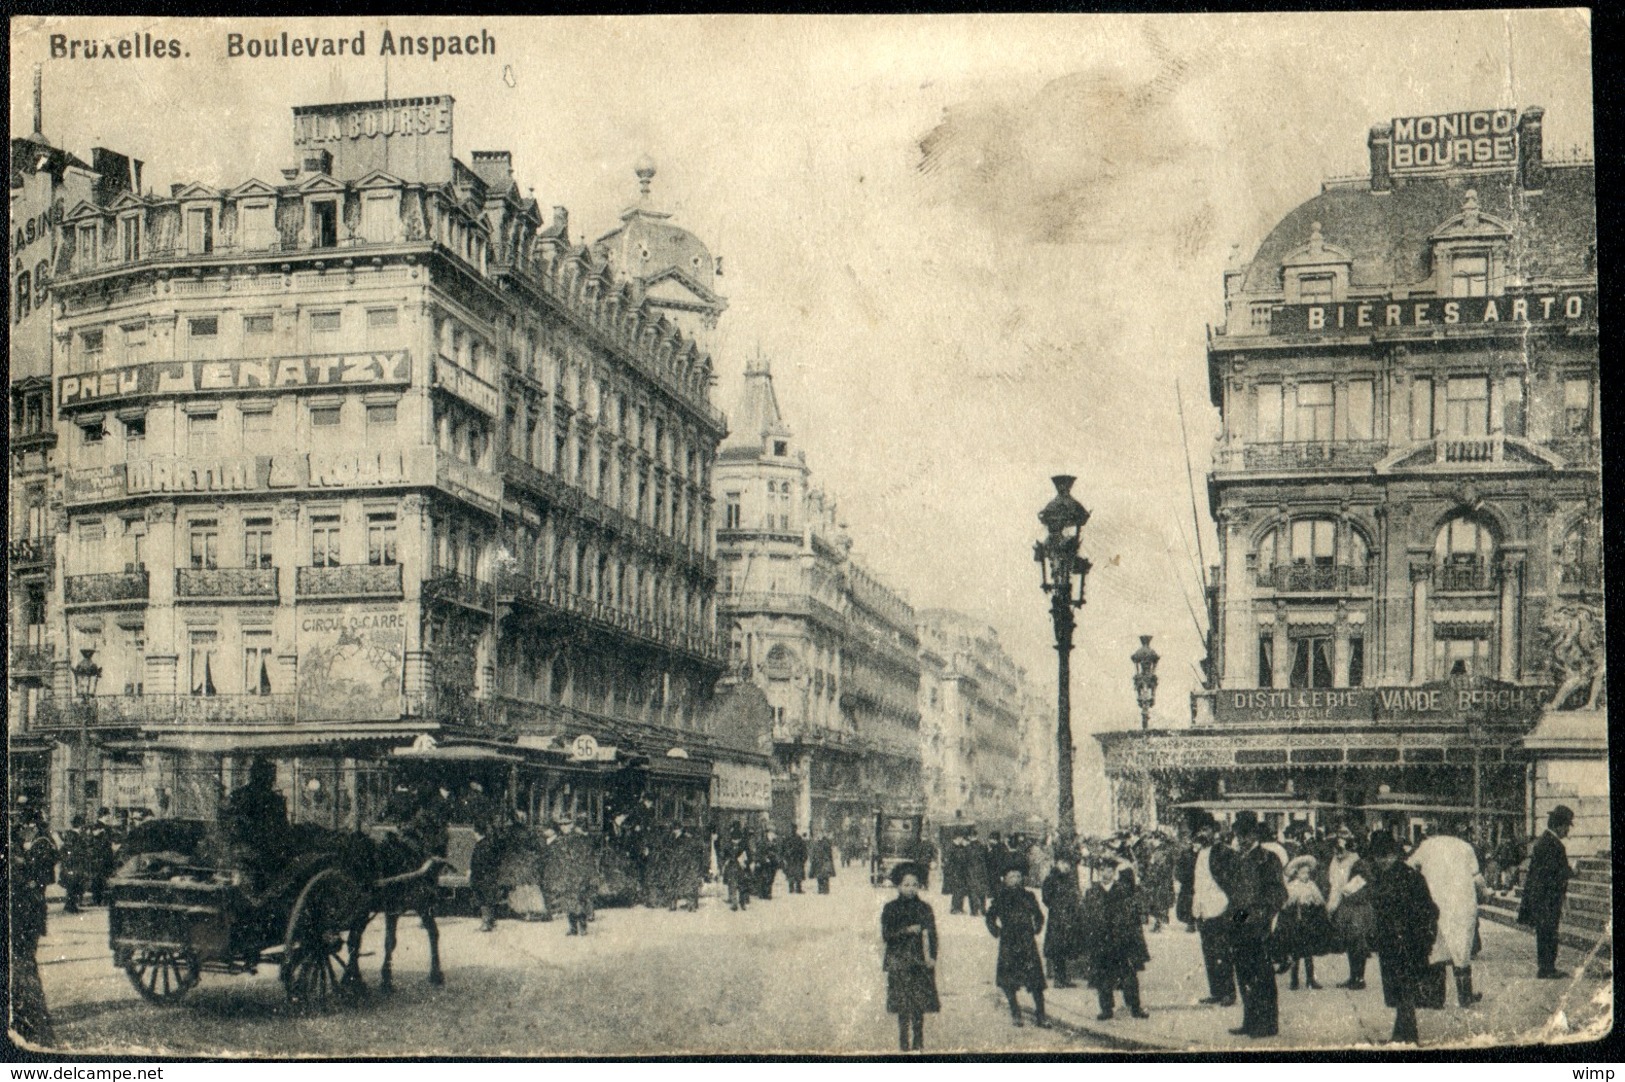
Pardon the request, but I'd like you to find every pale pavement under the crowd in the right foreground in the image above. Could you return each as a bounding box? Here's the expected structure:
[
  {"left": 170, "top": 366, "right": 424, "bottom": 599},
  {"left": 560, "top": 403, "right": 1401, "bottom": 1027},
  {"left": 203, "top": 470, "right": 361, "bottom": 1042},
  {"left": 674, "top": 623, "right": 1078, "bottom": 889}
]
[{"left": 1027, "top": 921, "right": 1614, "bottom": 1051}]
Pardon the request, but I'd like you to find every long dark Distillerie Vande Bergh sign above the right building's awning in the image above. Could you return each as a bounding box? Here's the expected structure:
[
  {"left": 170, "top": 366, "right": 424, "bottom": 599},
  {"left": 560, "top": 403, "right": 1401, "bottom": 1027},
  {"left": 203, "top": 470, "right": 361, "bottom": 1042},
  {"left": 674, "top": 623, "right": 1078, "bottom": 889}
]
[{"left": 1214, "top": 677, "right": 1552, "bottom": 725}]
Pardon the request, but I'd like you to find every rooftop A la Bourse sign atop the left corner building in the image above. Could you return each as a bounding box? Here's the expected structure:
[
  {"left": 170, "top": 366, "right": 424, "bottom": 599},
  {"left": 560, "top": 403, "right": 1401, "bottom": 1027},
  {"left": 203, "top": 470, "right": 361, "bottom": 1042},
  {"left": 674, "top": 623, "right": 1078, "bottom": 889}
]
[{"left": 294, "top": 94, "right": 453, "bottom": 184}]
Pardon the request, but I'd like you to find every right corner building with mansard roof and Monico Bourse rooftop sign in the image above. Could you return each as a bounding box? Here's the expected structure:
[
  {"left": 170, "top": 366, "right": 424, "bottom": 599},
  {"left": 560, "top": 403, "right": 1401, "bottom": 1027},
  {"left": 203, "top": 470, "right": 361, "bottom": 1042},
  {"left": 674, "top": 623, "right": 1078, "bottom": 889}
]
[{"left": 1100, "top": 109, "right": 1606, "bottom": 842}]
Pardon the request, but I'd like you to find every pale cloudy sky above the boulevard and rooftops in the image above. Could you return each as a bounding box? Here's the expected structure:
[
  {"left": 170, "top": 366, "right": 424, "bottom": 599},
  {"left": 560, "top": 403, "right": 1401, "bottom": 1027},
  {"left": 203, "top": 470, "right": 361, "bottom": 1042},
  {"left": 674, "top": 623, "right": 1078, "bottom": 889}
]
[{"left": 11, "top": 10, "right": 1593, "bottom": 829}]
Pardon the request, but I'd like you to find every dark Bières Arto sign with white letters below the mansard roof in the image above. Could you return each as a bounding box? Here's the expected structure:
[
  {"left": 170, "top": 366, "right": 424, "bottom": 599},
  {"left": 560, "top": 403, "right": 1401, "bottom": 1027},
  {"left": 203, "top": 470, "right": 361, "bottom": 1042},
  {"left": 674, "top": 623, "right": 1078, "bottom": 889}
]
[{"left": 1269, "top": 292, "right": 1597, "bottom": 335}]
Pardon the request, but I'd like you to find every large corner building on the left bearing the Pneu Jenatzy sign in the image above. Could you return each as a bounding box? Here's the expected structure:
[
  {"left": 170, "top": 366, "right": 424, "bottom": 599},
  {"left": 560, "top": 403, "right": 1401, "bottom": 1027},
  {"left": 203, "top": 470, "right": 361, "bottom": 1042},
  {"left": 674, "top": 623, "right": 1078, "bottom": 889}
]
[{"left": 41, "top": 97, "right": 744, "bottom": 825}]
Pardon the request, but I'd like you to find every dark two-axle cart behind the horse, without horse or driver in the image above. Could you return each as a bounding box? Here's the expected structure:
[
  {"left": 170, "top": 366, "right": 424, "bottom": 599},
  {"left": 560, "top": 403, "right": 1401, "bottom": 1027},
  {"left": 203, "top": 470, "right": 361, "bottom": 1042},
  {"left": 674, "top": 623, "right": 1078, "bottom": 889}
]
[{"left": 107, "top": 819, "right": 367, "bottom": 1007}]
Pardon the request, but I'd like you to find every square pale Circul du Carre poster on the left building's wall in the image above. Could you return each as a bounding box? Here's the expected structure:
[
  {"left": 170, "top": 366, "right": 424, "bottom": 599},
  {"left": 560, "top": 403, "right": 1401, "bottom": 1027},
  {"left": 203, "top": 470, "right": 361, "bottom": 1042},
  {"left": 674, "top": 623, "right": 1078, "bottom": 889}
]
[{"left": 297, "top": 604, "right": 406, "bottom": 721}]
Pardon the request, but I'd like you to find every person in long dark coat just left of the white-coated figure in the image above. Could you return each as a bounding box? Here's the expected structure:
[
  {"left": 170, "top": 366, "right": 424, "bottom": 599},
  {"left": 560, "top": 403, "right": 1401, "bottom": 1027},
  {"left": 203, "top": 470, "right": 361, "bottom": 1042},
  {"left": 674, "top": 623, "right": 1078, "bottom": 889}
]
[{"left": 1365, "top": 830, "right": 1438, "bottom": 1045}]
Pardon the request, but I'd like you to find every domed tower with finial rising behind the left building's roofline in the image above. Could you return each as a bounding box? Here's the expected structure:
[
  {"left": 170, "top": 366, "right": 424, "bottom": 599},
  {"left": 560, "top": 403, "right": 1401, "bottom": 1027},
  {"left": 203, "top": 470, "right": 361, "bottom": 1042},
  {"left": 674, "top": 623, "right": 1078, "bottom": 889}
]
[{"left": 593, "top": 154, "right": 728, "bottom": 351}]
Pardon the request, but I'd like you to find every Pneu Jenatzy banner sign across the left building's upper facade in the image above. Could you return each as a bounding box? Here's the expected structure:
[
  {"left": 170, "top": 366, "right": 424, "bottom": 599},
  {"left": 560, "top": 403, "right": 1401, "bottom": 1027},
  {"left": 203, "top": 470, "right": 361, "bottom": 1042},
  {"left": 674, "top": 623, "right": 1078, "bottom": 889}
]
[{"left": 57, "top": 349, "right": 411, "bottom": 408}]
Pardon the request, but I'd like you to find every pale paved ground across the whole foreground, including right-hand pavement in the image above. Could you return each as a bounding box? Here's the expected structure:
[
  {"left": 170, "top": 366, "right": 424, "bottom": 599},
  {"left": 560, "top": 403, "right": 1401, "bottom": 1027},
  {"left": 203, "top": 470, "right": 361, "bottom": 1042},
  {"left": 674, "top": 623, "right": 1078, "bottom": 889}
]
[{"left": 31, "top": 869, "right": 1612, "bottom": 1056}]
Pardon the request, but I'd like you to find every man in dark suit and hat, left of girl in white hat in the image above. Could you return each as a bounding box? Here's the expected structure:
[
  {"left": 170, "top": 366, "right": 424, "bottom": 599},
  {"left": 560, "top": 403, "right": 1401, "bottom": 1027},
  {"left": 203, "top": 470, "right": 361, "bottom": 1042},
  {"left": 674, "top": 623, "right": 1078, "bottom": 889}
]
[{"left": 1214, "top": 811, "right": 1287, "bottom": 1037}]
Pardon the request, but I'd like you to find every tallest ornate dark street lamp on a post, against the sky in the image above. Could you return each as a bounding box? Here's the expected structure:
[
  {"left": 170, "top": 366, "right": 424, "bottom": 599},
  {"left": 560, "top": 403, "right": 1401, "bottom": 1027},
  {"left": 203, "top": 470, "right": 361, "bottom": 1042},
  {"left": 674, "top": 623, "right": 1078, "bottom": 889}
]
[{"left": 1032, "top": 474, "right": 1092, "bottom": 843}]
